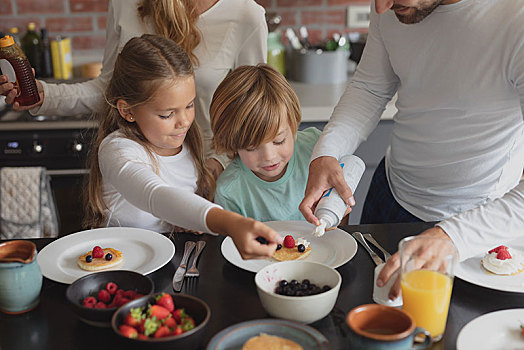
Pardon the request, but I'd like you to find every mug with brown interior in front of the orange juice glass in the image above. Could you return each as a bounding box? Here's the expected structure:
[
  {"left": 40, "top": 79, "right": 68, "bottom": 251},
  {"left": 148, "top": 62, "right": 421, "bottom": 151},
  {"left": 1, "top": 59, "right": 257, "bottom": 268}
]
[{"left": 346, "top": 304, "right": 432, "bottom": 350}]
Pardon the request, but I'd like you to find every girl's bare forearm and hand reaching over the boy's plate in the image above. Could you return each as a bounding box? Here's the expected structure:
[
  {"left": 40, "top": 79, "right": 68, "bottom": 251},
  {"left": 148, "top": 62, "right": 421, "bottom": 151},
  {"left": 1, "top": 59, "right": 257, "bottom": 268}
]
[{"left": 206, "top": 208, "right": 283, "bottom": 259}]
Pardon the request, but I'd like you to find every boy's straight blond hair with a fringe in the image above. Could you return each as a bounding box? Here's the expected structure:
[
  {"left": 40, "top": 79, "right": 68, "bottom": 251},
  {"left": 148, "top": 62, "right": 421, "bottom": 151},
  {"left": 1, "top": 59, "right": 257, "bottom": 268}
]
[{"left": 209, "top": 64, "right": 301, "bottom": 158}]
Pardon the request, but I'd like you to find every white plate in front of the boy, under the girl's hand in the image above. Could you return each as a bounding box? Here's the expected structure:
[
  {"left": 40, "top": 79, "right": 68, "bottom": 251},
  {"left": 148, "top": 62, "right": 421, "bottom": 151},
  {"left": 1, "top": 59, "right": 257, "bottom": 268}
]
[{"left": 221, "top": 221, "right": 357, "bottom": 272}]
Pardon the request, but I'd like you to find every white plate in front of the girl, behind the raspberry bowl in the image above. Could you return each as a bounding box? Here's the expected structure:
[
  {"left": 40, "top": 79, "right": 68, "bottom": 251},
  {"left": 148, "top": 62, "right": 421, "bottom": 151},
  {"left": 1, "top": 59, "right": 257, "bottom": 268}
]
[{"left": 37, "top": 227, "right": 175, "bottom": 283}]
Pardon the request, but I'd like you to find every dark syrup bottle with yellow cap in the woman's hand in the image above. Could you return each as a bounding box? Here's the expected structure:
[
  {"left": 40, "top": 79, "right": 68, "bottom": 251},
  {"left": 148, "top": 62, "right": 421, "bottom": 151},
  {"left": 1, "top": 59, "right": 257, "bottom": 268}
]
[{"left": 0, "top": 35, "right": 40, "bottom": 106}]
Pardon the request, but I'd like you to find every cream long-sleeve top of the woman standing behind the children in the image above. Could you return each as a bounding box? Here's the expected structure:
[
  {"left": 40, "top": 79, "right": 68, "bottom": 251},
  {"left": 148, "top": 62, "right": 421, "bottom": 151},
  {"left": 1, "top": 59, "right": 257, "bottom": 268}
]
[{"left": 31, "top": 0, "right": 267, "bottom": 165}]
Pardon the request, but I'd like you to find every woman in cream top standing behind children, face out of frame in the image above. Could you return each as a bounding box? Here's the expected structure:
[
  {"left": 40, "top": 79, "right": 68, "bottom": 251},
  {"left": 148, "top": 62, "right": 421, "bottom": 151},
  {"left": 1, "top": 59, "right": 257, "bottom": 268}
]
[{"left": 0, "top": 0, "right": 267, "bottom": 177}]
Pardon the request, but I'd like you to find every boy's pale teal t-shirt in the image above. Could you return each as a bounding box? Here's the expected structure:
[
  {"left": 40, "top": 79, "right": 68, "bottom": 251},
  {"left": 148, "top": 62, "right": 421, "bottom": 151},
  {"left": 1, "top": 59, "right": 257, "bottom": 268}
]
[{"left": 215, "top": 128, "right": 320, "bottom": 221}]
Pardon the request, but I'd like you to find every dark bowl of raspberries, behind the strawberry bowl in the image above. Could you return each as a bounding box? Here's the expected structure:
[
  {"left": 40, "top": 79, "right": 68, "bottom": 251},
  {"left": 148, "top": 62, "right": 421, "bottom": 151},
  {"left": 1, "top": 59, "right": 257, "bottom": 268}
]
[{"left": 66, "top": 270, "right": 154, "bottom": 327}]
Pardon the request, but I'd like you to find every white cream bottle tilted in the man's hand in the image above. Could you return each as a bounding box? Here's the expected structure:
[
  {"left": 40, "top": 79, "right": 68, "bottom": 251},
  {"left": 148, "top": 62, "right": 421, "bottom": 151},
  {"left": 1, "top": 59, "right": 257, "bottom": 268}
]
[{"left": 315, "top": 154, "right": 366, "bottom": 236}]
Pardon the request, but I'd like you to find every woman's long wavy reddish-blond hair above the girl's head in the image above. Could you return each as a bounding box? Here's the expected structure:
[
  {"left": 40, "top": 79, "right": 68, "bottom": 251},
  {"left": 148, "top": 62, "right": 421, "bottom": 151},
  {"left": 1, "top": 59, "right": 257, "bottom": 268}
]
[{"left": 138, "top": 0, "right": 201, "bottom": 65}]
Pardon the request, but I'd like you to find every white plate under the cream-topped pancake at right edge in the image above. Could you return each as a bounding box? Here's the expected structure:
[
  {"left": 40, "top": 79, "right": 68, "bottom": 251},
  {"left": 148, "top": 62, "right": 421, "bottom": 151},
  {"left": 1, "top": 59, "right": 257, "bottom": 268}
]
[{"left": 455, "top": 239, "right": 524, "bottom": 292}]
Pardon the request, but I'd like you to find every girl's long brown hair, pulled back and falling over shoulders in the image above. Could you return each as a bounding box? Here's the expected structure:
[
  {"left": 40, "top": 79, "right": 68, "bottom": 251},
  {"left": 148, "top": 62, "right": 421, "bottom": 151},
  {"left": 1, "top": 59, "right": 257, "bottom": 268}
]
[{"left": 84, "top": 34, "right": 215, "bottom": 227}]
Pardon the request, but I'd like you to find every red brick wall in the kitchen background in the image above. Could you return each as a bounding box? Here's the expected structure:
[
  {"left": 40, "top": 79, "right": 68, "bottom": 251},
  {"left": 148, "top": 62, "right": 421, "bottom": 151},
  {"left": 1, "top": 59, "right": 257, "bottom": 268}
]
[{"left": 0, "top": 0, "right": 369, "bottom": 57}]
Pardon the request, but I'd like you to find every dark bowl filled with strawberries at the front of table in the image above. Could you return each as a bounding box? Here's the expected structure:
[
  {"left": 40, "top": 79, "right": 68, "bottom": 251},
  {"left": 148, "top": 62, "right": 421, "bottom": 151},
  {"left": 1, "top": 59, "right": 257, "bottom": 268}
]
[{"left": 111, "top": 293, "right": 211, "bottom": 349}]
